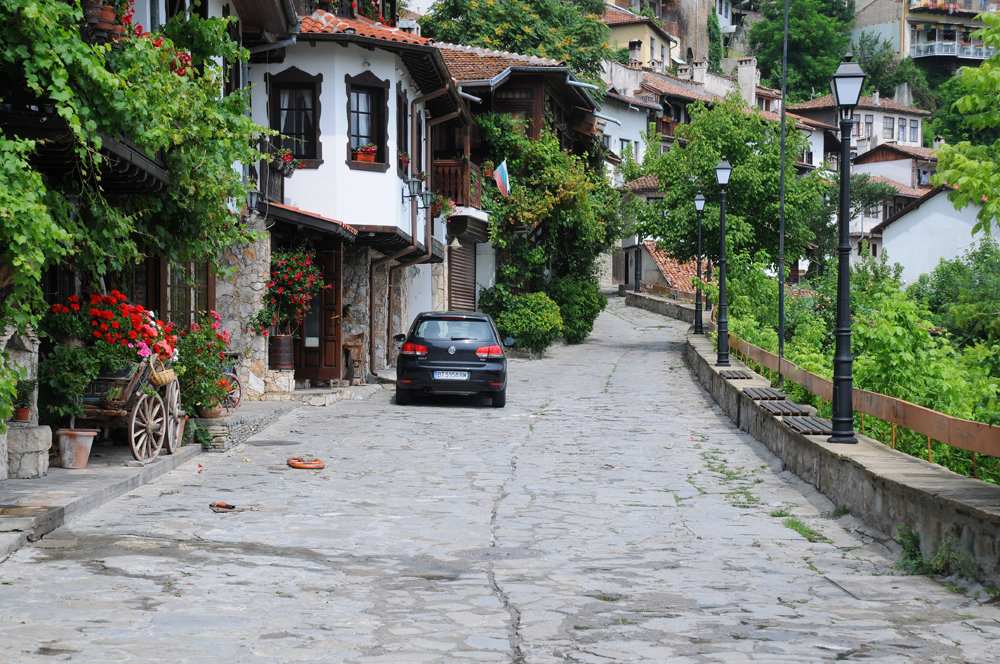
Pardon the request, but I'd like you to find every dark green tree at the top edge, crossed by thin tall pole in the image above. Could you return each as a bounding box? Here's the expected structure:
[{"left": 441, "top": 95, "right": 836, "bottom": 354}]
[{"left": 748, "top": 0, "right": 853, "bottom": 102}]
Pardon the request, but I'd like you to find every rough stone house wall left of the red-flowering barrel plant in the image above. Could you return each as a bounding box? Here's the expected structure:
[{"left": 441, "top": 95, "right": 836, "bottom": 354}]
[{"left": 215, "top": 213, "right": 271, "bottom": 399}]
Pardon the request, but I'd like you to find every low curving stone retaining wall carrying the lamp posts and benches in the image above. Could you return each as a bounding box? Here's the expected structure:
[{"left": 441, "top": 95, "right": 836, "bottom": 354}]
[{"left": 629, "top": 294, "right": 1000, "bottom": 586}]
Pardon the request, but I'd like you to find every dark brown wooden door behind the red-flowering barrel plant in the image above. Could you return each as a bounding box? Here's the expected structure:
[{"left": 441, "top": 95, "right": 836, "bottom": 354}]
[{"left": 295, "top": 245, "right": 344, "bottom": 380}]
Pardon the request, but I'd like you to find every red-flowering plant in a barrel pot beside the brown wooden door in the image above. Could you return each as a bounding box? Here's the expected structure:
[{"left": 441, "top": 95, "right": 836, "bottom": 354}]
[{"left": 250, "top": 248, "right": 329, "bottom": 371}]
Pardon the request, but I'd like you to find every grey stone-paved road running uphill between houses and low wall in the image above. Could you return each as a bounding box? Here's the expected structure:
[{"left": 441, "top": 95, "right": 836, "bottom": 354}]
[{"left": 0, "top": 298, "right": 1000, "bottom": 664}]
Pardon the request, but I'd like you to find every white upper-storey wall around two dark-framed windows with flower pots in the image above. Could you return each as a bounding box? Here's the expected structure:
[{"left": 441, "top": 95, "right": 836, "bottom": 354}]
[{"left": 250, "top": 42, "right": 432, "bottom": 242}]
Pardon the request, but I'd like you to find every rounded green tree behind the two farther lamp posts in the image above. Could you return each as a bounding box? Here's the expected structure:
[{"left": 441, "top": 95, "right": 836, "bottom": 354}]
[{"left": 639, "top": 95, "right": 830, "bottom": 264}]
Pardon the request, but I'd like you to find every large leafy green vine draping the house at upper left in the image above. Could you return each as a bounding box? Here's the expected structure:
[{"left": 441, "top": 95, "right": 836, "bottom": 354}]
[{"left": 0, "top": 0, "right": 268, "bottom": 421}]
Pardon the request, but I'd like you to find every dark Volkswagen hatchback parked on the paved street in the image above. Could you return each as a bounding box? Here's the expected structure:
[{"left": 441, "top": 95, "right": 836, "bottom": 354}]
[{"left": 393, "top": 311, "right": 513, "bottom": 408}]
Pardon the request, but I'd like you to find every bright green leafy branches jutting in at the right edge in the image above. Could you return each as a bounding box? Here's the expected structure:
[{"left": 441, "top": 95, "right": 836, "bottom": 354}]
[{"left": 932, "top": 14, "right": 1000, "bottom": 234}]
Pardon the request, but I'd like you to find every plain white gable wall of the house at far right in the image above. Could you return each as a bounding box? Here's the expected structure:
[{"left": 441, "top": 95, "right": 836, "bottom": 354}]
[{"left": 882, "top": 192, "right": 978, "bottom": 284}]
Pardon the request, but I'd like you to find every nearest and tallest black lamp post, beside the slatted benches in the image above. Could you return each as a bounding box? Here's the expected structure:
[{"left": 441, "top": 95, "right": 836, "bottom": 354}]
[{"left": 829, "top": 53, "right": 865, "bottom": 443}]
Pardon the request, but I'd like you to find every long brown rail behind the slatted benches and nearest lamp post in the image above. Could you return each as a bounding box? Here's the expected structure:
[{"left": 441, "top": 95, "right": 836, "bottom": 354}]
[{"left": 729, "top": 334, "right": 1000, "bottom": 464}]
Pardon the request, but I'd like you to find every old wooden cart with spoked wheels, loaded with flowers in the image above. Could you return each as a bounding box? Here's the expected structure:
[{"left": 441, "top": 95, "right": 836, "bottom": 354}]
[{"left": 79, "top": 356, "right": 184, "bottom": 461}]
